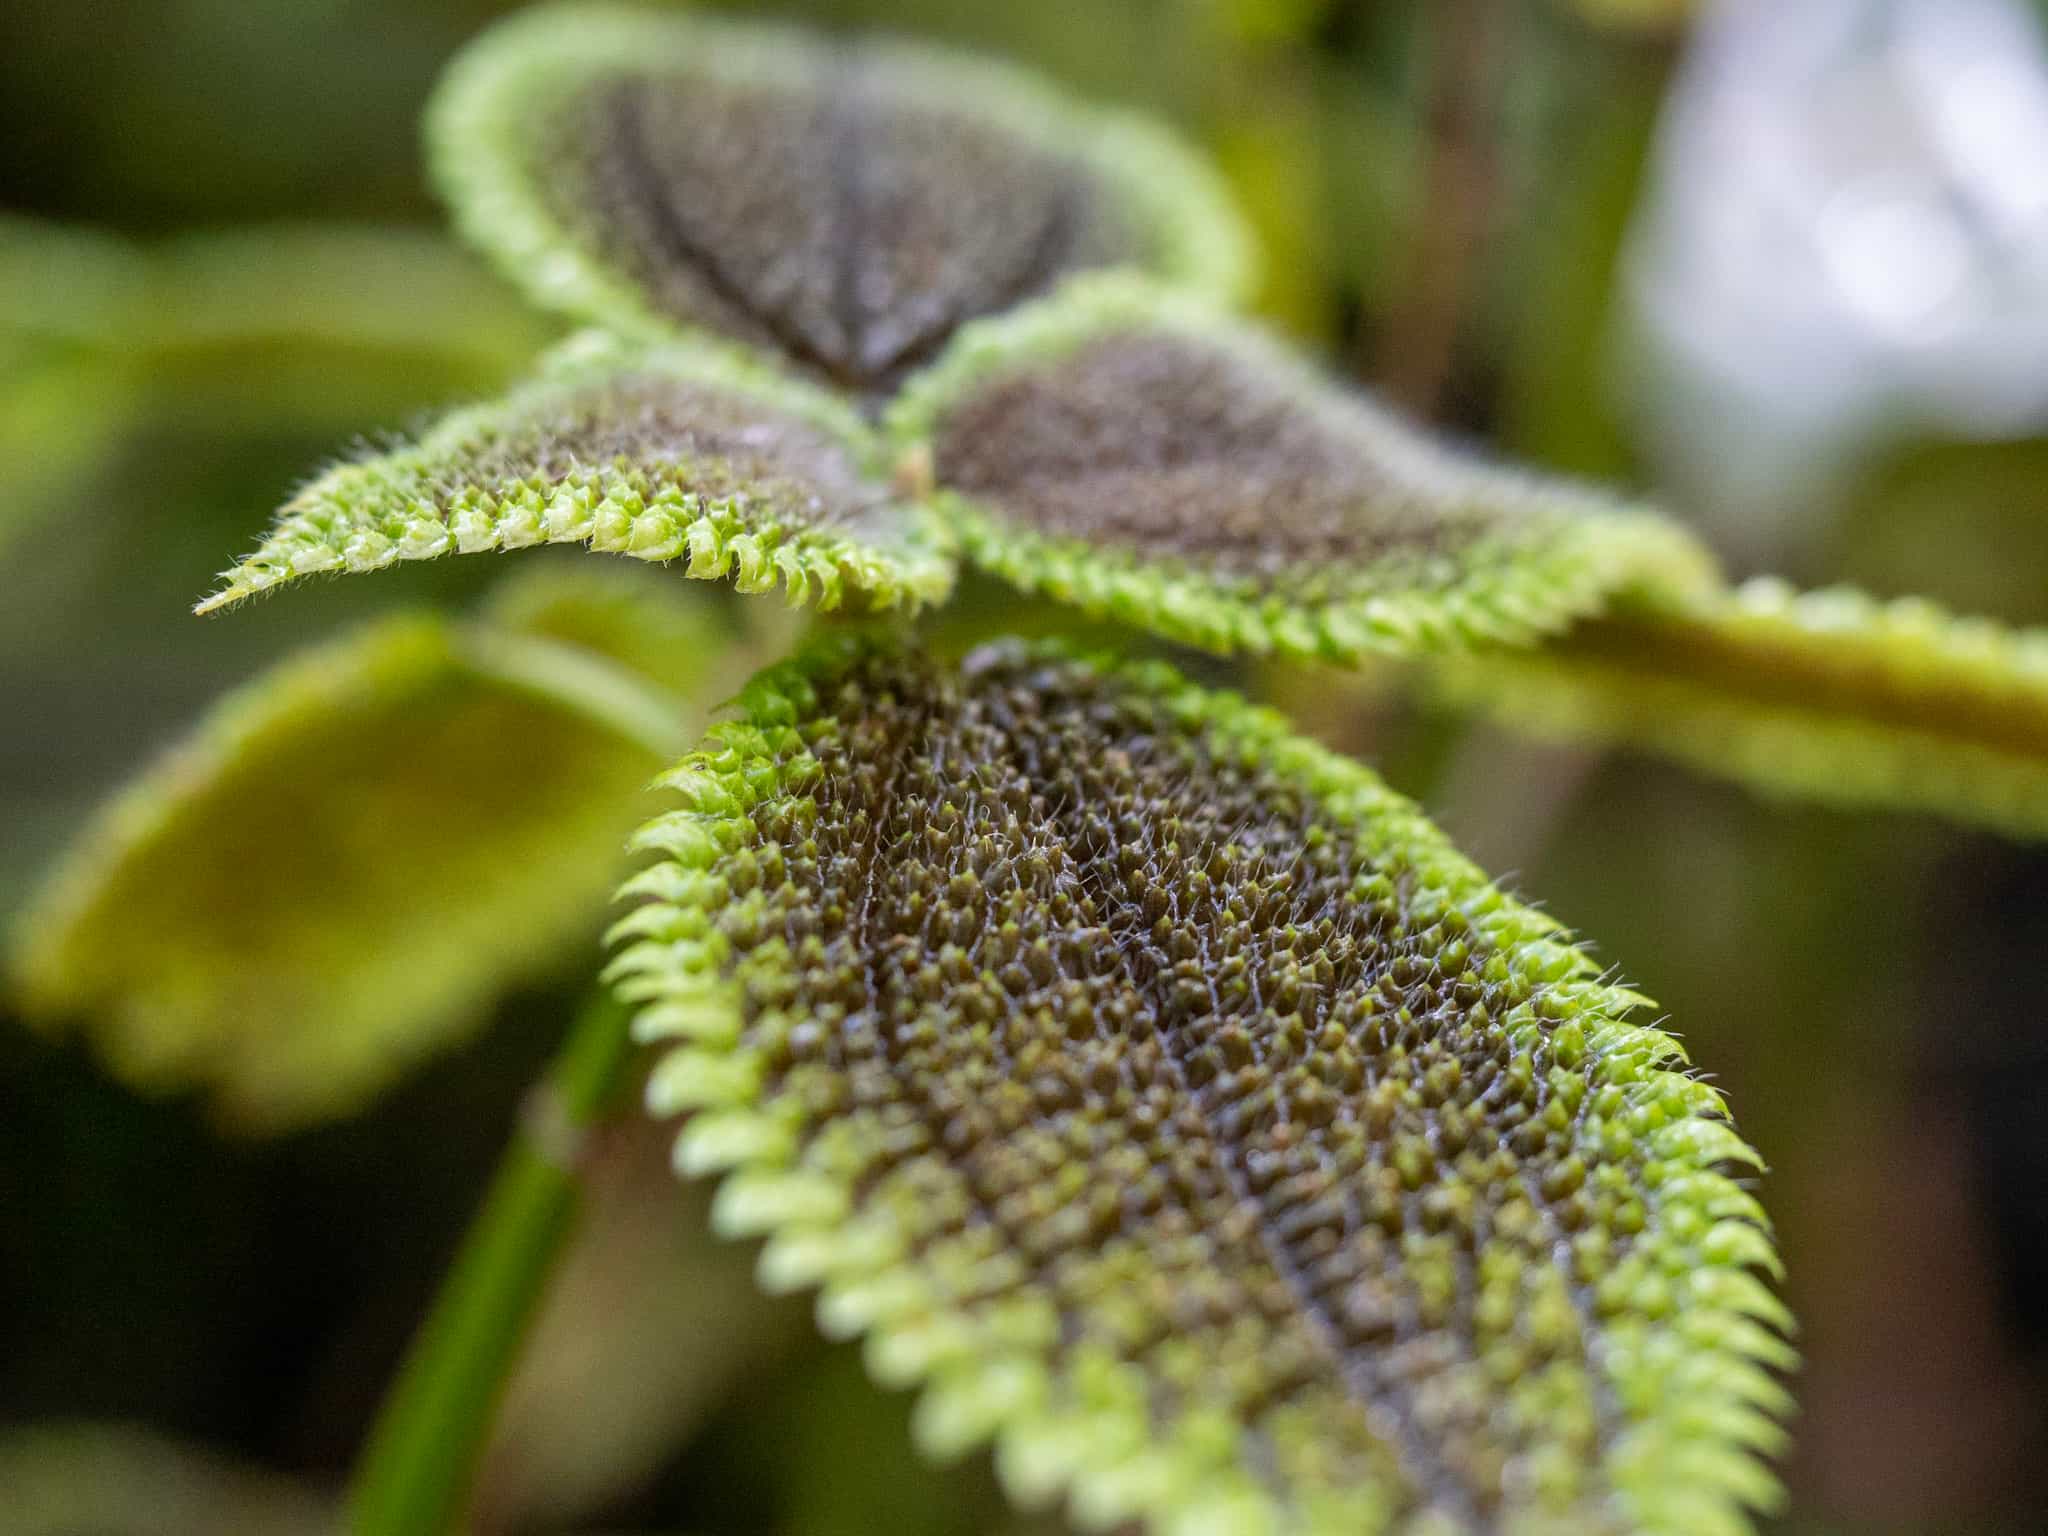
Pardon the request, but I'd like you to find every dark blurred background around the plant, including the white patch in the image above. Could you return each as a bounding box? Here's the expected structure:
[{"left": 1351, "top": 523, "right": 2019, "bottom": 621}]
[{"left": 0, "top": 0, "right": 2048, "bottom": 1536}]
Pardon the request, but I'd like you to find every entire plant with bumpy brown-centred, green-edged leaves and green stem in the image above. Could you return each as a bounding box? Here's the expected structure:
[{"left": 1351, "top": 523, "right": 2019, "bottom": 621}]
[{"left": 16, "top": 6, "right": 2048, "bottom": 1536}]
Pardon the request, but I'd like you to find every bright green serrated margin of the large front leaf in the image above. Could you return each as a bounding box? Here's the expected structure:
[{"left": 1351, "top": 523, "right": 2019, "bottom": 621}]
[{"left": 606, "top": 633, "right": 1794, "bottom": 1536}]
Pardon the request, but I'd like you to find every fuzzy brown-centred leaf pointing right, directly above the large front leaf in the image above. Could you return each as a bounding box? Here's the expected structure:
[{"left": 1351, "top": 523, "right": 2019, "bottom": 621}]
[{"left": 891, "top": 279, "right": 1714, "bottom": 662}]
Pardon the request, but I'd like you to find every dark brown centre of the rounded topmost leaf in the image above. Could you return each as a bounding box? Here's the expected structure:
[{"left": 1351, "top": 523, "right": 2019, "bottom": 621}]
[{"left": 547, "top": 67, "right": 1137, "bottom": 391}]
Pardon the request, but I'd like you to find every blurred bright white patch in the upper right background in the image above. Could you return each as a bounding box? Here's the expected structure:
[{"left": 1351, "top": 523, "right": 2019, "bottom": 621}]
[{"left": 1622, "top": 0, "right": 2048, "bottom": 563}]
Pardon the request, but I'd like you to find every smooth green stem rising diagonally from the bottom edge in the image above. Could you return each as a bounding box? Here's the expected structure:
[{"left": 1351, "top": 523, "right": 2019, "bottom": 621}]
[{"left": 348, "top": 993, "right": 631, "bottom": 1536}]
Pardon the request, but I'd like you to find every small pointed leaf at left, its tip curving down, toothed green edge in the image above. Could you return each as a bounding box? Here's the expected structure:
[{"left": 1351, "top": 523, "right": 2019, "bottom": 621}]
[{"left": 199, "top": 334, "right": 952, "bottom": 612}]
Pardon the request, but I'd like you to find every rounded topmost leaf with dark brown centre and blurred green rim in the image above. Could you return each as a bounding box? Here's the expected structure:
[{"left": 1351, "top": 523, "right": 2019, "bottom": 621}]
[{"left": 428, "top": 6, "right": 1247, "bottom": 393}]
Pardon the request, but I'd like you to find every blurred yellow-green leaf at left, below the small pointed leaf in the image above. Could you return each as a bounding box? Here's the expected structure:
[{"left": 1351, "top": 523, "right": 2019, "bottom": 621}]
[{"left": 12, "top": 571, "right": 731, "bottom": 1130}]
